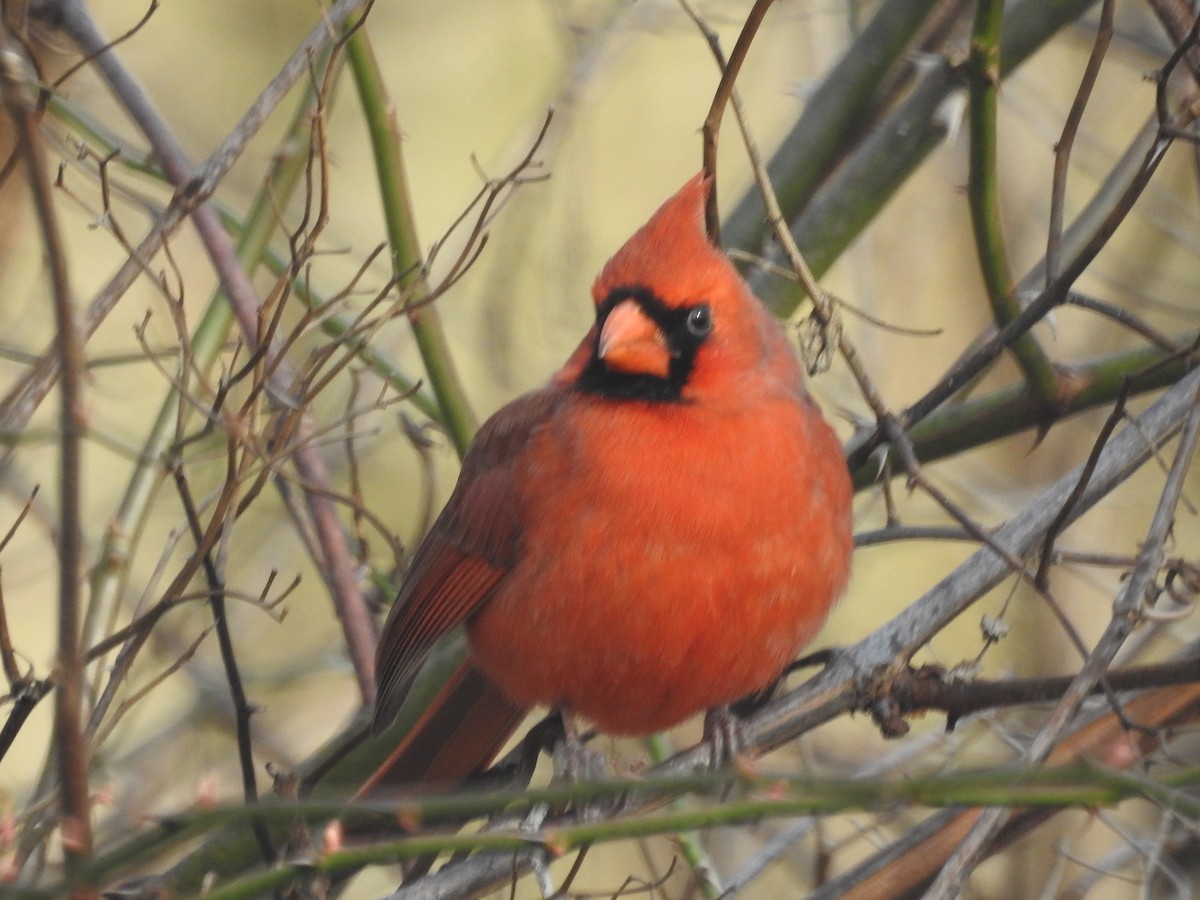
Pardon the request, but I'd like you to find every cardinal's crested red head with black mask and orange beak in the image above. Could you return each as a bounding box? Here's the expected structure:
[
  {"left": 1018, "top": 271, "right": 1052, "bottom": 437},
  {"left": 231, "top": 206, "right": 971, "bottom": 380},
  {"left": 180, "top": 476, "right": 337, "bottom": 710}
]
[{"left": 569, "top": 174, "right": 800, "bottom": 402}]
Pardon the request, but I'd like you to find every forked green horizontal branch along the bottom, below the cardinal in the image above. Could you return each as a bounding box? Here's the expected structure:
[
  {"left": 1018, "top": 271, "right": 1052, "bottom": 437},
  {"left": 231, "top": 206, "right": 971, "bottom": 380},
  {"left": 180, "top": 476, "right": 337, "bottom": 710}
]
[{"left": 75, "top": 763, "right": 1200, "bottom": 900}]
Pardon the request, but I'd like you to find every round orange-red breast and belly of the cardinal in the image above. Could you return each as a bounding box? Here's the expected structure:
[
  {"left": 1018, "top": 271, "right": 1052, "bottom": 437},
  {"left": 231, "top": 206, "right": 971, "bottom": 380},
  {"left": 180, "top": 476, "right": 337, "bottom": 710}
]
[{"left": 468, "top": 393, "right": 852, "bottom": 734}]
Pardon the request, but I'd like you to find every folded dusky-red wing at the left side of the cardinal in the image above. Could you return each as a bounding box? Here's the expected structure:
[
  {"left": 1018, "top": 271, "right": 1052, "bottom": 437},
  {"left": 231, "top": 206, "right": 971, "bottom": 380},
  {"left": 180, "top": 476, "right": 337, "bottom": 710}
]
[{"left": 374, "top": 389, "right": 559, "bottom": 732}]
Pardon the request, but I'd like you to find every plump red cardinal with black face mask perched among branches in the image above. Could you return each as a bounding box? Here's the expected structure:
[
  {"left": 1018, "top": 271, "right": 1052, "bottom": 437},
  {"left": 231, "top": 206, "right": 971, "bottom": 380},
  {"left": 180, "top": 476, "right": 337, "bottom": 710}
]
[{"left": 376, "top": 175, "right": 852, "bottom": 781}]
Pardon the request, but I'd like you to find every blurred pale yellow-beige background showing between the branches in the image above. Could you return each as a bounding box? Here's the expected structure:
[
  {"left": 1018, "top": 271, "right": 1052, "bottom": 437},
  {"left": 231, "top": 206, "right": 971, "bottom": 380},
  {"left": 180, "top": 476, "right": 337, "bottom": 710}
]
[{"left": 0, "top": 0, "right": 1200, "bottom": 898}]
